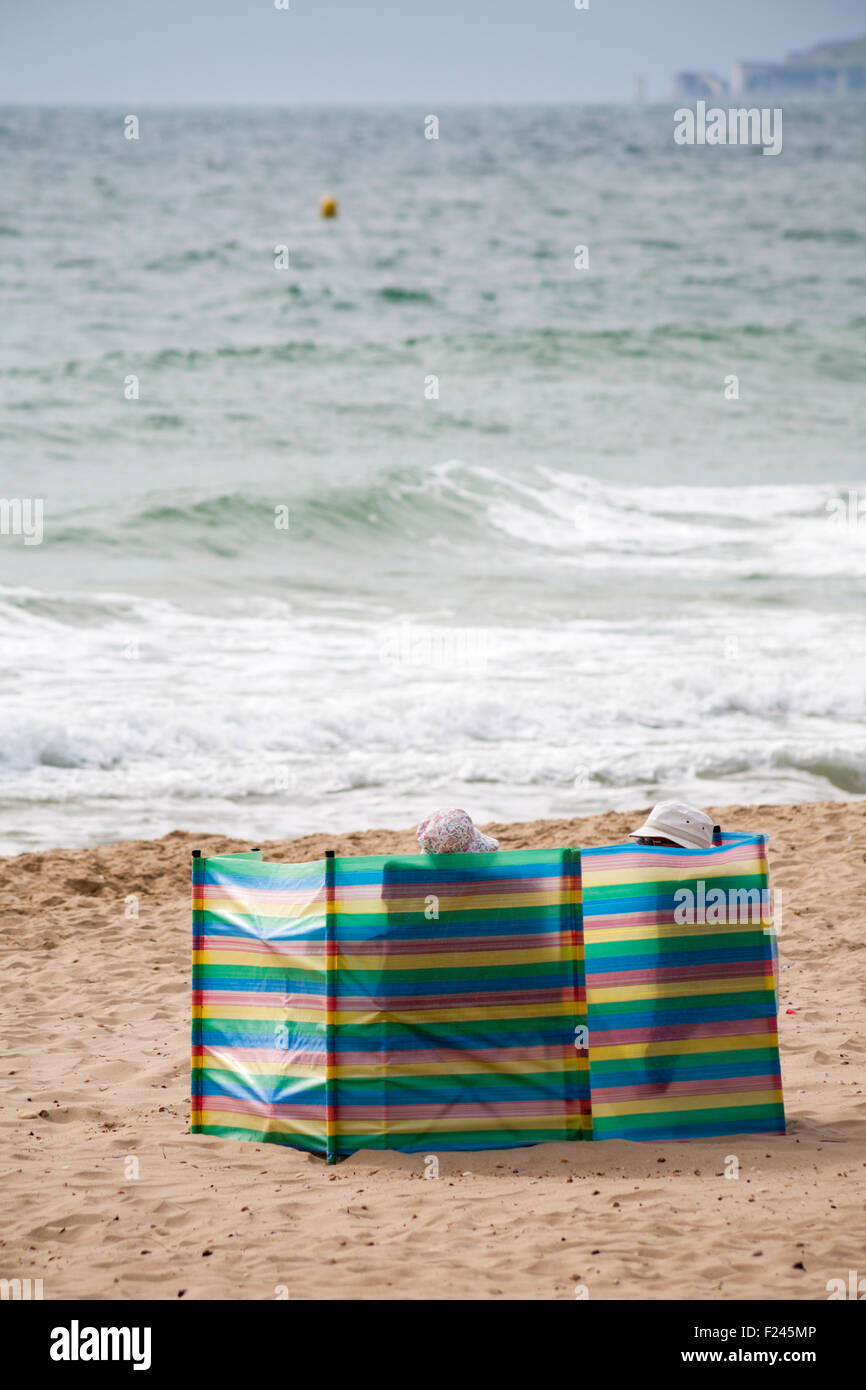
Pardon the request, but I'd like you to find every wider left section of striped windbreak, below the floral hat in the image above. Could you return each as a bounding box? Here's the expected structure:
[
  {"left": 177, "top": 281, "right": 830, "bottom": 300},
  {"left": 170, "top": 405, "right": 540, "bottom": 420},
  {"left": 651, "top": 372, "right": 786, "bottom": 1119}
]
[{"left": 192, "top": 849, "right": 589, "bottom": 1159}]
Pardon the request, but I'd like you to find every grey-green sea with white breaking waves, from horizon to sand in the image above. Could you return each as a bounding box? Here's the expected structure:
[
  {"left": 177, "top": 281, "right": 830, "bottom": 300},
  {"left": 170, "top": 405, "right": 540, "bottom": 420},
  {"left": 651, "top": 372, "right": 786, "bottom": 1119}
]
[{"left": 0, "top": 101, "right": 866, "bottom": 853}]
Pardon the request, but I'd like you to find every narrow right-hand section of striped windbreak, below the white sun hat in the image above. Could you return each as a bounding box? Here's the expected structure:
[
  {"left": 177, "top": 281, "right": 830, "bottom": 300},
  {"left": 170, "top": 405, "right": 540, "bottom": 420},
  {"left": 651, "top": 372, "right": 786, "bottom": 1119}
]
[{"left": 582, "top": 835, "right": 785, "bottom": 1140}]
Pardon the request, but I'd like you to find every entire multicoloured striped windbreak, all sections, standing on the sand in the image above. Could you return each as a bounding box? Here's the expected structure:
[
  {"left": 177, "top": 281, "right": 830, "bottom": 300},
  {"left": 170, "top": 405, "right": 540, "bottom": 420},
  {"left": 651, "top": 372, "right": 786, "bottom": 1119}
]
[{"left": 192, "top": 835, "right": 784, "bottom": 1161}]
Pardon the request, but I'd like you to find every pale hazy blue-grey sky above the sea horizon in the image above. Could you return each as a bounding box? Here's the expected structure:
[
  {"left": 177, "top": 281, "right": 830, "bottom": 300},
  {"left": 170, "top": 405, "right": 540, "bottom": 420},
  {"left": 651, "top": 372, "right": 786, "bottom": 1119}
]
[{"left": 0, "top": 0, "right": 866, "bottom": 110}]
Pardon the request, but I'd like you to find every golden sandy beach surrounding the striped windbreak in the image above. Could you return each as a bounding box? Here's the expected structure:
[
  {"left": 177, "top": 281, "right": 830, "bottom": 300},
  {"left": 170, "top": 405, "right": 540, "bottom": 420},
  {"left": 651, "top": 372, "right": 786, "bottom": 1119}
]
[{"left": 0, "top": 802, "right": 866, "bottom": 1300}]
